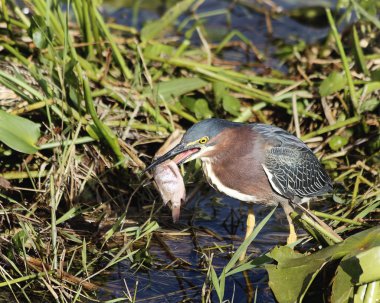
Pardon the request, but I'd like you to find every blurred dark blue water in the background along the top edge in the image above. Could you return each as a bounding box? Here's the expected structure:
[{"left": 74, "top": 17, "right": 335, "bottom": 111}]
[{"left": 104, "top": 0, "right": 336, "bottom": 71}]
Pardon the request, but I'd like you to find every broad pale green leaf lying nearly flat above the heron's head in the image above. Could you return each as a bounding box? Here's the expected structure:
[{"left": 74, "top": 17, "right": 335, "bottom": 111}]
[{"left": 152, "top": 77, "right": 208, "bottom": 101}]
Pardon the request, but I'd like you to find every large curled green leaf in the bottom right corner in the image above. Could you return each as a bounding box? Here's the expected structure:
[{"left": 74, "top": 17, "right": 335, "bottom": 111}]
[{"left": 265, "top": 227, "right": 380, "bottom": 303}]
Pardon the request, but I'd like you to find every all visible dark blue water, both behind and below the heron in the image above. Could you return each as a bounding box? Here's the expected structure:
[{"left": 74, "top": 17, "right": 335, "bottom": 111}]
[{"left": 99, "top": 0, "right": 333, "bottom": 302}]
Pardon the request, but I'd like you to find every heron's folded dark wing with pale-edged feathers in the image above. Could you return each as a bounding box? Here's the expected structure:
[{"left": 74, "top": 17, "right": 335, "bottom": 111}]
[{"left": 253, "top": 123, "right": 332, "bottom": 199}]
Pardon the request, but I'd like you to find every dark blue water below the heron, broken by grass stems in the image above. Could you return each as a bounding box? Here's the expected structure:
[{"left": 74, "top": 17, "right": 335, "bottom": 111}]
[{"left": 95, "top": 190, "right": 300, "bottom": 302}]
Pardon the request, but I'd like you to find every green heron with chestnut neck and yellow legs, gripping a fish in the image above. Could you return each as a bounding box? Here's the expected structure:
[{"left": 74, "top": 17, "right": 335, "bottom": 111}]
[{"left": 146, "top": 119, "right": 332, "bottom": 259}]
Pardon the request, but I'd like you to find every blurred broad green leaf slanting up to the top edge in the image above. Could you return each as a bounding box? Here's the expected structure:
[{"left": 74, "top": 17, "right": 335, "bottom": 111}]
[{"left": 141, "top": 0, "right": 195, "bottom": 42}]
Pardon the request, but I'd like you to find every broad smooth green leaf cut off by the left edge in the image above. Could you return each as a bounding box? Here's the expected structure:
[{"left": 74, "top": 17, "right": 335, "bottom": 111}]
[{"left": 0, "top": 110, "right": 41, "bottom": 154}]
